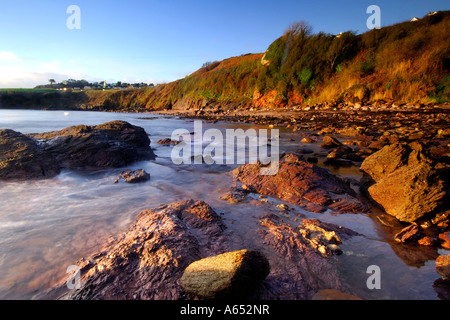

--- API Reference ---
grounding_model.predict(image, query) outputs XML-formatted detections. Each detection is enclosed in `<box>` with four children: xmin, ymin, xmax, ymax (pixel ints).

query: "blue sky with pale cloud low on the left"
<box><xmin>0</xmin><ymin>0</ymin><xmax>450</xmax><ymax>88</ymax></box>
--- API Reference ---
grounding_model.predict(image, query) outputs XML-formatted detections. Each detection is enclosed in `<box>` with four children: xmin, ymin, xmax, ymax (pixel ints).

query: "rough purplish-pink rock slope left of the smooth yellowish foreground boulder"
<box><xmin>55</xmin><ymin>200</ymin><xmax>227</xmax><ymax>300</ymax></box>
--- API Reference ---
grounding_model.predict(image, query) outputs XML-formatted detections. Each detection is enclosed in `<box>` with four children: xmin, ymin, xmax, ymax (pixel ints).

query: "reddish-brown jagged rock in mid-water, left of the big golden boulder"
<box><xmin>233</xmin><ymin>154</ymin><xmax>367</xmax><ymax>213</ymax></box>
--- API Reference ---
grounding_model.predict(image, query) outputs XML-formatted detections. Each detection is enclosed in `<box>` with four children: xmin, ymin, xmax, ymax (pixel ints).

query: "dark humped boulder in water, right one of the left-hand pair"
<box><xmin>32</xmin><ymin>121</ymin><xmax>155</xmax><ymax>169</ymax></box>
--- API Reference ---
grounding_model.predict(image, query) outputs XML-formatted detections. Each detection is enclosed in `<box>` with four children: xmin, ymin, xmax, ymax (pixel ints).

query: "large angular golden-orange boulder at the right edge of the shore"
<box><xmin>361</xmin><ymin>143</ymin><xmax>447</xmax><ymax>222</ymax></box>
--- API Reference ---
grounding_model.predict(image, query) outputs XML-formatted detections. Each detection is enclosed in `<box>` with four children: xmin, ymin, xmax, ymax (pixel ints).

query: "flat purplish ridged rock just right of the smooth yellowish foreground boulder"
<box><xmin>257</xmin><ymin>214</ymin><xmax>358</xmax><ymax>300</ymax></box>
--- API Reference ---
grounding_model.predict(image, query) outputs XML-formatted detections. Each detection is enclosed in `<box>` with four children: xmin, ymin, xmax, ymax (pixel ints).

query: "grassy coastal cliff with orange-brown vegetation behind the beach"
<box><xmin>0</xmin><ymin>11</ymin><xmax>450</xmax><ymax>112</ymax></box>
